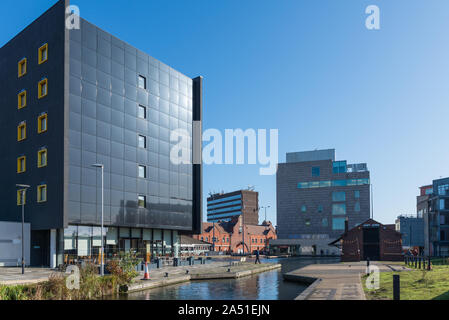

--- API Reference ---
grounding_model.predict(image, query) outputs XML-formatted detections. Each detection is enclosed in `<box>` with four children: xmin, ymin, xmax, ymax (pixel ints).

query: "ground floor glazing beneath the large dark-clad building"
<box><xmin>48</xmin><ymin>225</ymin><xmax>180</xmax><ymax>267</ymax></box>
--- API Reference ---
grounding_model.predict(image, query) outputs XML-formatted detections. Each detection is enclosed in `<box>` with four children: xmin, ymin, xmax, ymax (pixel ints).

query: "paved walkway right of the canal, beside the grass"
<box><xmin>284</xmin><ymin>261</ymin><xmax>409</xmax><ymax>300</ymax></box>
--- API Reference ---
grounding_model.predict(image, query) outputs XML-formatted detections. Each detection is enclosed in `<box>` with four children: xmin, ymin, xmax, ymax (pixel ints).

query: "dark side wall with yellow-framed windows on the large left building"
<box><xmin>0</xmin><ymin>1</ymin><xmax>65</xmax><ymax>230</ymax></box>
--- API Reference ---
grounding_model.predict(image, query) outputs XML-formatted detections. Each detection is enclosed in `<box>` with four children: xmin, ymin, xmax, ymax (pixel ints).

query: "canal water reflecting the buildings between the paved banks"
<box><xmin>117</xmin><ymin>257</ymin><xmax>340</xmax><ymax>300</ymax></box>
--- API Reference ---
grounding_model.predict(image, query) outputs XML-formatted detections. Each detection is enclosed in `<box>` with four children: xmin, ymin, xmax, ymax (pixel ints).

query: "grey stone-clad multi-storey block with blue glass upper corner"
<box><xmin>272</xmin><ymin>149</ymin><xmax>371</xmax><ymax>254</ymax></box>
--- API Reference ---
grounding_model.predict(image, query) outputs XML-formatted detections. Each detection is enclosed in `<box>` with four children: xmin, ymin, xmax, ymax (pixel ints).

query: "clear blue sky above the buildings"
<box><xmin>0</xmin><ymin>0</ymin><xmax>449</xmax><ymax>223</ymax></box>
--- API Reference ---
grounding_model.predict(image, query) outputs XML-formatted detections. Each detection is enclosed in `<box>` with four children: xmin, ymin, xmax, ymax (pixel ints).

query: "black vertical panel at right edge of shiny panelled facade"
<box><xmin>192</xmin><ymin>77</ymin><xmax>203</xmax><ymax>233</ymax></box>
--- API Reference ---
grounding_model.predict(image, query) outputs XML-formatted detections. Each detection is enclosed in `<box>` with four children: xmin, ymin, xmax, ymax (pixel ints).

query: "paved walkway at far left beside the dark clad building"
<box><xmin>0</xmin><ymin>267</ymin><xmax>60</xmax><ymax>285</ymax></box>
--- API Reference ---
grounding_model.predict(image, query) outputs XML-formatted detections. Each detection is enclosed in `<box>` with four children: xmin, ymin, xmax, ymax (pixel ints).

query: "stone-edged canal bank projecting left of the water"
<box><xmin>123</xmin><ymin>262</ymin><xmax>281</xmax><ymax>293</ymax></box>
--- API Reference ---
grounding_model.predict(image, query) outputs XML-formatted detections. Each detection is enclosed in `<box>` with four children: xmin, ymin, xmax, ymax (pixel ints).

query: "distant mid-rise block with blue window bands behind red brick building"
<box><xmin>207</xmin><ymin>190</ymin><xmax>259</xmax><ymax>225</ymax></box>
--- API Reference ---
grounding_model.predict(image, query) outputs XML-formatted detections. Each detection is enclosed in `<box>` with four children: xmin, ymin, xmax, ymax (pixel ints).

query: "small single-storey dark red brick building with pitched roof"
<box><xmin>329</xmin><ymin>219</ymin><xmax>403</xmax><ymax>261</ymax></box>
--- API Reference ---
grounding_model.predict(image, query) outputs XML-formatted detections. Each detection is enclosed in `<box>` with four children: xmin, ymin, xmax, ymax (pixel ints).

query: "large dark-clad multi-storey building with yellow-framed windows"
<box><xmin>0</xmin><ymin>1</ymin><xmax>202</xmax><ymax>266</ymax></box>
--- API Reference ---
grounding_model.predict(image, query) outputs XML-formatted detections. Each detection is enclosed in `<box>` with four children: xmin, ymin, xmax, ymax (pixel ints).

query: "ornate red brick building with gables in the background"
<box><xmin>192</xmin><ymin>216</ymin><xmax>276</xmax><ymax>253</ymax></box>
